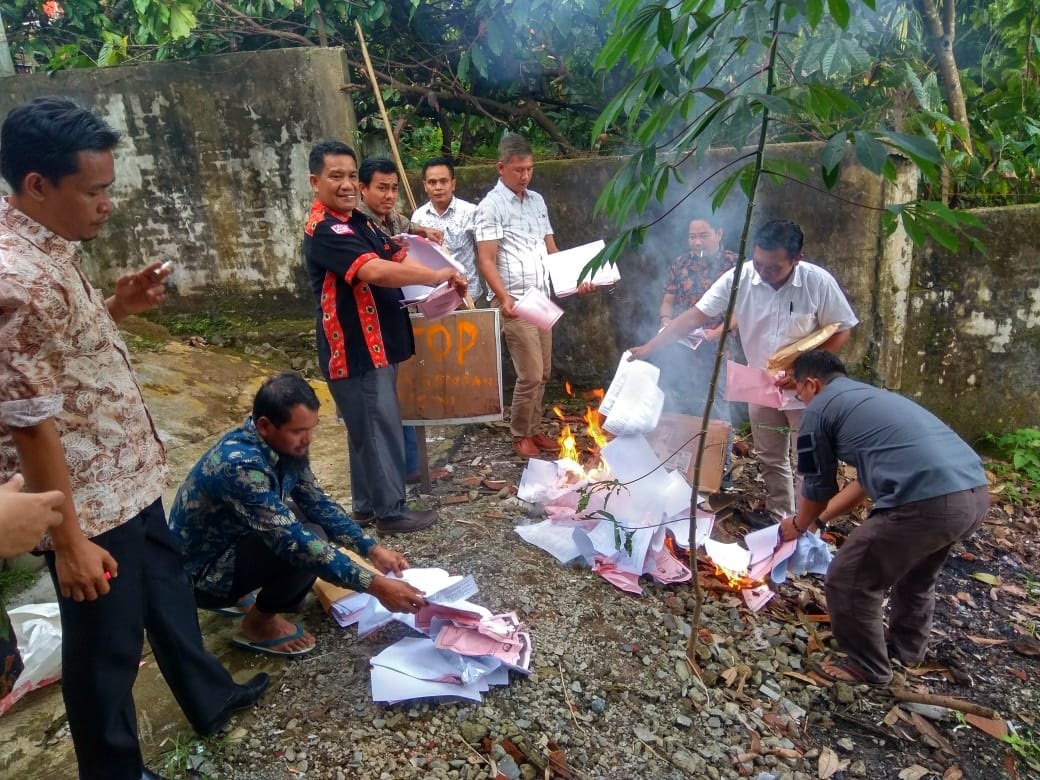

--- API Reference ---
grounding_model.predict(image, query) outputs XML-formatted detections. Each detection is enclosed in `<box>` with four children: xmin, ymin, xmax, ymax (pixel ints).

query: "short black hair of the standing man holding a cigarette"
<box><xmin>0</xmin><ymin>96</ymin><xmax>120</xmax><ymax>192</ymax></box>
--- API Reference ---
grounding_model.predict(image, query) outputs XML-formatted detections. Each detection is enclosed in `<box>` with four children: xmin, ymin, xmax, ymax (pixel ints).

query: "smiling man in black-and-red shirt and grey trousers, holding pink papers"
<box><xmin>304</xmin><ymin>141</ymin><xmax>466</xmax><ymax>534</ymax></box>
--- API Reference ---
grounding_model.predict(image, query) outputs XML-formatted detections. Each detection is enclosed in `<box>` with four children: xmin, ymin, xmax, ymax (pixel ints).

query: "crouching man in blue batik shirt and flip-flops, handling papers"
<box><xmin>170</xmin><ymin>373</ymin><xmax>425</xmax><ymax>655</ymax></box>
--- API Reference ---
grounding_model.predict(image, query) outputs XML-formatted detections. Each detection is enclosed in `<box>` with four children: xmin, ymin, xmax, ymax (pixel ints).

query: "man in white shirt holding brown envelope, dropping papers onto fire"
<box><xmin>631</xmin><ymin>219</ymin><xmax>859</xmax><ymax>518</ymax></box>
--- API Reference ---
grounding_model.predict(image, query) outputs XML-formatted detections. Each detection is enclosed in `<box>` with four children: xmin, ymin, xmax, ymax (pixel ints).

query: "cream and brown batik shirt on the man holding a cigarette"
<box><xmin>0</xmin><ymin>201</ymin><xmax>166</xmax><ymax>550</ymax></box>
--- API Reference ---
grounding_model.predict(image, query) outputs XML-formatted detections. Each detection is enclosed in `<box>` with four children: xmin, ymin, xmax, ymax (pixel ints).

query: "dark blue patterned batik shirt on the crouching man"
<box><xmin>170</xmin><ymin>418</ymin><xmax>376</xmax><ymax>597</ymax></box>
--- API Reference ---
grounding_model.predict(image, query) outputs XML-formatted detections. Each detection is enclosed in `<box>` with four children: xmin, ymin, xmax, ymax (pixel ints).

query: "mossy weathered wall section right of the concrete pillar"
<box><xmin>903</xmin><ymin>205</ymin><xmax>1040</xmax><ymax>441</ymax></box>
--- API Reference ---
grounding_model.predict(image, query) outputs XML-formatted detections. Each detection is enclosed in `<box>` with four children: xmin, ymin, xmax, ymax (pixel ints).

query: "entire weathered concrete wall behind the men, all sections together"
<box><xmin>0</xmin><ymin>49</ymin><xmax>1040</xmax><ymax>437</ymax></box>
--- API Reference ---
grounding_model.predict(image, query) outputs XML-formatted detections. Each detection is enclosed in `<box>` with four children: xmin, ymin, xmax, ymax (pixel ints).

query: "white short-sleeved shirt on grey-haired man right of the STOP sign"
<box><xmin>473</xmin><ymin>180</ymin><xmax>552</xmax><ymax>301</ymax></box>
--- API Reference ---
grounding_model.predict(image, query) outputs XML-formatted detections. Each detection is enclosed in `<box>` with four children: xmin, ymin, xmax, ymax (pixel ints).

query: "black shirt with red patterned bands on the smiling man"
<box><xmin>304</xmin><ymin>201</ymin><xmax>415</xmax><ymax>380</ymax></box>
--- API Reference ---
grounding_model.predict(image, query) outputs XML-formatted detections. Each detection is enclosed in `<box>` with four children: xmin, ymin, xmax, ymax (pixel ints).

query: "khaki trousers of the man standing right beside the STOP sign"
<box><xmin>491</xmin><ymin>297</ymin><xmax>552</xmax><ymax>437</ymax></box>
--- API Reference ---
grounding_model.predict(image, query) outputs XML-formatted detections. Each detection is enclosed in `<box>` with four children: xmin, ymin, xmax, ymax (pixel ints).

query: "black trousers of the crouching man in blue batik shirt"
<box><xmin>196</xmin><ymin>526</ymin><xmax>328</xmax><ymax>614</ymax></box>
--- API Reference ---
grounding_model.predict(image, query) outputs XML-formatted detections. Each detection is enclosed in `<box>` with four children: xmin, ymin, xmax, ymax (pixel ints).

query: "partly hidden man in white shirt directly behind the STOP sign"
<box><xmin>412</xmin><ymin>157</ymin><xmax>484</xmax><ymax>301</ymax></box>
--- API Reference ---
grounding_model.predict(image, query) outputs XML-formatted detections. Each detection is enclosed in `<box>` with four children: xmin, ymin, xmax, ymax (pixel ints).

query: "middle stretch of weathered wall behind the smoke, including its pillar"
<box><xmin>445</xmin><ymin>144</ymin><xmax>886</xmax><ymax>391</ymax></box>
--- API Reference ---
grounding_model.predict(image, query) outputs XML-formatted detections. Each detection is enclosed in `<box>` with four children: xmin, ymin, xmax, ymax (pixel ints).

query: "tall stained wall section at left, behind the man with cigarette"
<box><xmin>0</xmin><ymin>49</ymin><xmax>356</xmax><ymax>294</ymax></box>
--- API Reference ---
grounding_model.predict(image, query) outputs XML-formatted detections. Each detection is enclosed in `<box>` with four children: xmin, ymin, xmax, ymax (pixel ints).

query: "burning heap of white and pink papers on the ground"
<box><xmin>507</xmin><ymin>354</ymin><xmax>830</xmax><ymax>610</ymax></box>
